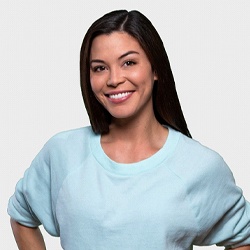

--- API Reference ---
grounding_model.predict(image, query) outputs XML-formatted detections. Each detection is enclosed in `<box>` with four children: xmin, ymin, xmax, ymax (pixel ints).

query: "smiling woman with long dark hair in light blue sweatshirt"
<box><xmin>8</xmin><ymin>10</ymin><xmax>250</xmax><ymax>250</ymax></box>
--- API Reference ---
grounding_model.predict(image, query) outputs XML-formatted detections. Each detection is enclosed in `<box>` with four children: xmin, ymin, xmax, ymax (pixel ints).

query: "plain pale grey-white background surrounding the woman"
<box><xmin>0</xmin><ymin>0</ymin><xmax>250</xmax><ymax>250</ymax></box>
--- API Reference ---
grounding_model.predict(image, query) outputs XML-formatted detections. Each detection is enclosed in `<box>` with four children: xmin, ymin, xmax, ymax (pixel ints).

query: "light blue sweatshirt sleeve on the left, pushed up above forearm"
<box><xmin>8</xmin><ymin>142</ymin><xmax>59</xmax><ymax>236</ymax></box>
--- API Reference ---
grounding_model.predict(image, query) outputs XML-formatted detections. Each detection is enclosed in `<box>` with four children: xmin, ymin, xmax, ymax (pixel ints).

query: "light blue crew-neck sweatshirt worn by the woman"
<box><xmin>8</xmin><ymin>127</ymin><xmax>250</xmax><ymax>250</ymax></box>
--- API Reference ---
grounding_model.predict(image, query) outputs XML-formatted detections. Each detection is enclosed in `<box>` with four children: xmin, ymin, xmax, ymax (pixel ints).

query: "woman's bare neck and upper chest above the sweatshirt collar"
<box><xmin>101</xmin><ymin>112</ymin><xmax>168</xmax><ymax>163</ymax></box>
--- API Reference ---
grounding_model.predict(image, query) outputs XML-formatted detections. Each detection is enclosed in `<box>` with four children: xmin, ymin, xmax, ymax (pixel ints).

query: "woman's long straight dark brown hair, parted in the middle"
<box><xmin>80</xmin><ymin>10</ymin><xmax>191</xmax><ymax>137</ymax></box>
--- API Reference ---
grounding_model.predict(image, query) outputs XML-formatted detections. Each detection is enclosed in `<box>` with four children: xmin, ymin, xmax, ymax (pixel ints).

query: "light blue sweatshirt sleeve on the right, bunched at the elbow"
<box><xmin>191</xmin><ymin>157</ymin><xmax>250</xmax><ymax>249</ymax></box>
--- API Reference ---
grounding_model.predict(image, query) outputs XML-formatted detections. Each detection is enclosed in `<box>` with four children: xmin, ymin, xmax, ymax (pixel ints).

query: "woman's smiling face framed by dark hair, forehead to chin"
<box><xmin>90</xmin><ymin>32</ymin><xmax>157</xmax><ymax>119</ymax></box>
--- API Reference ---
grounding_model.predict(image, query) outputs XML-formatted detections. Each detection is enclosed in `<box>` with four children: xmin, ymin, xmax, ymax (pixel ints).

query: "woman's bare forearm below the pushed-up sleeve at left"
<box><xmin>10</xmin><ymin>219</ymin><xmax>46</xmax><ymax>250</ymax></box>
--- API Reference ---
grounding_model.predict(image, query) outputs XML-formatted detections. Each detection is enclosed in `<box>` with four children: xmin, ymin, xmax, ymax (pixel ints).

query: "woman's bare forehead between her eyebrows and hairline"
<box><xmin>90</xmin><ymin>32</ymin><xmax>145</xmax><ymax>58</ymax></box>
